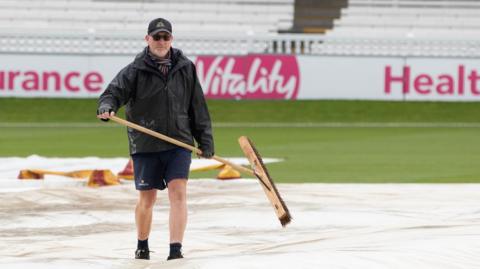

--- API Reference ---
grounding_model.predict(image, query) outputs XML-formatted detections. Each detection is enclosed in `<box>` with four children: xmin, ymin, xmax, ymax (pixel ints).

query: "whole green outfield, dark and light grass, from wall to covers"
<box><xmin>0</xmin><ymin>98</ymin><xmax>480</xmax><ymax>182</ymax></box>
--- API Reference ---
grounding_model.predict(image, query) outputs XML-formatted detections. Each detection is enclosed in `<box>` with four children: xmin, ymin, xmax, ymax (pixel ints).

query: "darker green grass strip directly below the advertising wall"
<box><xmin>0</xmin><ymin>98</ymin><xmax>480</xmax><ymax>122</ymax></box>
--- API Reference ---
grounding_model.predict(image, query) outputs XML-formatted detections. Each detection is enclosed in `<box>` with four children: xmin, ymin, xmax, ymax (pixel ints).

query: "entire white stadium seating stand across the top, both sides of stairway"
<box><xmin>0</xmin><ymin>0</ymin><xmax>480</xmax><ymax>57</ymax></box>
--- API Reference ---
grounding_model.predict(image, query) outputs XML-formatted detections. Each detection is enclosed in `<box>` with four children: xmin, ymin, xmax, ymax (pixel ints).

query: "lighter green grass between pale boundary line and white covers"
<box><xmin>0</xmin><ymin>123</ymin><xmax>480</xmax><ymax>182</ymax></box>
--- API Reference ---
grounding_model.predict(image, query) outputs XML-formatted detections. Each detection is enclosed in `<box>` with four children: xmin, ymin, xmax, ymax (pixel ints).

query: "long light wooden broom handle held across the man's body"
<box><xmin>110</xmin><ymin>116</ymin><xmax>255</xmax><ymax>176</ymax></box>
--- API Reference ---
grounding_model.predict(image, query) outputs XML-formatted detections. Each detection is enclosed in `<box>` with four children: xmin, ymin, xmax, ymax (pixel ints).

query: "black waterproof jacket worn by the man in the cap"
<box><xmin>98</xmin><ymin>47</ymin><xmax>214</xmax><ymax>154</ymax></box>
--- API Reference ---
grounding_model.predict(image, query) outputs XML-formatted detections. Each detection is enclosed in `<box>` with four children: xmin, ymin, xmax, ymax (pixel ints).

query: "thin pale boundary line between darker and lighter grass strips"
<box><xmin>0</xmin><ymin>122</ymin><xmax>480</xmax><ymax>128</ymax></box>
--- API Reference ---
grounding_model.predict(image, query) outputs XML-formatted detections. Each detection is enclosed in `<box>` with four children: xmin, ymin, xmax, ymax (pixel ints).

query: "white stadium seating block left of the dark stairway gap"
<box><xmin>0</xmin><ymin>0</ymin><xmax>294</xmax><ymax>54</ymax></box>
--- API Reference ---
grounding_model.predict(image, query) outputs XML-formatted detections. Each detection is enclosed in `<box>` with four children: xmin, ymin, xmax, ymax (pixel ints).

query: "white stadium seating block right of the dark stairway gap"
<box><xmin>313</xmin><ymin>0</ymin><xmax>480</xmax><ymax>57</ymax></box>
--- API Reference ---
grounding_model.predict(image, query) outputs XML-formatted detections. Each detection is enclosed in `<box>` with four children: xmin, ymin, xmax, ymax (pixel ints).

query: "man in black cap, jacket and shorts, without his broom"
<box><xmin>97</xmin><ymin>18</ymin><xmax>214</xmax><ymax>260</ymax></box>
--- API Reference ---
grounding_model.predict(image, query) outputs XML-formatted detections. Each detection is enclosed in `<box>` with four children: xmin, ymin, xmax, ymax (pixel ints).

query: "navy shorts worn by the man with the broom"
<box><xmin>132</xmin><ymin>148</ymin><xmax>192</xmax><ymax>190</ymax></box>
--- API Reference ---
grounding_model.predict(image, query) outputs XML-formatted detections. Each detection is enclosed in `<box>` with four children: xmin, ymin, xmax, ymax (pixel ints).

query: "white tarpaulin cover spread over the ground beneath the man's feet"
<box><xmin>0</xmin><ymin>157</ymin><xmax>480</xmax><ymax>269</ymax></box>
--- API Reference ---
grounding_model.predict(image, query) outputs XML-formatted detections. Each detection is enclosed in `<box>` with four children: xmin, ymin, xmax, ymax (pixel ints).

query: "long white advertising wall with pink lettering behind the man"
<box><xmin>0</xmin><ymin>54</ymin><xmax>480</xmax><ymax>101</ymax></box>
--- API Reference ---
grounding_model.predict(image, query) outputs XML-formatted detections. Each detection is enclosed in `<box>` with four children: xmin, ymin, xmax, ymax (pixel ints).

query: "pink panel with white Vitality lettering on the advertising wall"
<box><xmin>195</xmin><ymin>55</ymin><xmax>300</xmax><ymax>99</ymax></box>
